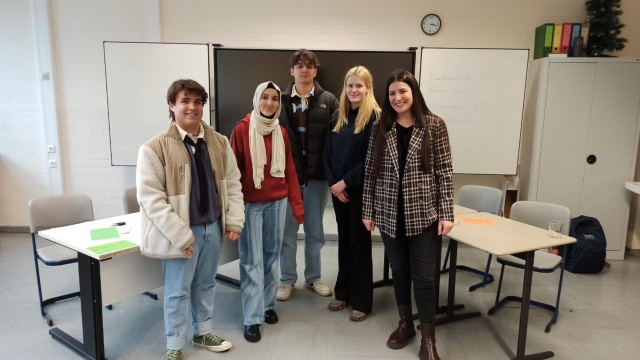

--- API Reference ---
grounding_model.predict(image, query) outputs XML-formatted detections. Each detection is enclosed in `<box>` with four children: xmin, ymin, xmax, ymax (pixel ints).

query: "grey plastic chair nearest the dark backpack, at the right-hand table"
<box><xmin>489</xmin><ymin>201</ymin><xmax>571</xmax><ymax>332</ymax></box>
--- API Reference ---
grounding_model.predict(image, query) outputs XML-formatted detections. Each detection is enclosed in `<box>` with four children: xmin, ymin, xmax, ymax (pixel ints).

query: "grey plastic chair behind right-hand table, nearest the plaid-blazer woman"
<box><xmin>440</xmin><ymin>185</ymin><xmax>504</xmax><ymax>291</ymax></box>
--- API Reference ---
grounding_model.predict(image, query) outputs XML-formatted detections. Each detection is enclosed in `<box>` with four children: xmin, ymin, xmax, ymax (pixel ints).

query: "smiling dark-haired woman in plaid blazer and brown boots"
<box><xmin>362</xmin><ymin>70</ymin><xmax>453</xmax><ymax>360</ymax></box>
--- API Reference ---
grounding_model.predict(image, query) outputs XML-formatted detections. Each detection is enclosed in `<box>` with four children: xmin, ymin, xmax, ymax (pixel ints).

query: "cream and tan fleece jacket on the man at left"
<box><xmin>136</xmin><ymin>122</ymin><xmax>244</xmax><ymax>259</ymax></box>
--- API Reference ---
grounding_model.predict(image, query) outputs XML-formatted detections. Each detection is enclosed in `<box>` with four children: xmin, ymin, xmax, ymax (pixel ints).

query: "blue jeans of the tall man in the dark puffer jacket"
<box><xmin>280</xmin><ymin>180</ymin><xmax>329</xmax><ymax>285</ymax></box>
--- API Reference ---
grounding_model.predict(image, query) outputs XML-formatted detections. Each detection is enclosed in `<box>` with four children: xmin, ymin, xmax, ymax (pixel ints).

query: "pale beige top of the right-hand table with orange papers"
<box><xmin>447</xmin><ymin>212</ymin><xmax>576</xmax><ymax>256</ymax></box>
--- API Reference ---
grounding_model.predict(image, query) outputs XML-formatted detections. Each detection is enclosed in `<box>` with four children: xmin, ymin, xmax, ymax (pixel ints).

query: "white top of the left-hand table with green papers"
<box><xmin>38</xmin><ymin>213</ymin><xmax>140</xmax><ymax>260</ymax></box>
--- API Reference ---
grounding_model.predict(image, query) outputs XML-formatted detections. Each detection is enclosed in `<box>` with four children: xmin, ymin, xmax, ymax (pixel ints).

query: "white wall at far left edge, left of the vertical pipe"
<box><xmin>0</xmin><ymin>0</ymin><xmax>49</xmax><ymax>226</ymax></box>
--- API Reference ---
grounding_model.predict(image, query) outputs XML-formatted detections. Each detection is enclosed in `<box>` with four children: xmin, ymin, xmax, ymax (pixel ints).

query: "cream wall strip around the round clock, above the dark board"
<box><xmin>161</xmin><ymin>0</ymin><xmax>584</xmax><ymax>49</ymax></box>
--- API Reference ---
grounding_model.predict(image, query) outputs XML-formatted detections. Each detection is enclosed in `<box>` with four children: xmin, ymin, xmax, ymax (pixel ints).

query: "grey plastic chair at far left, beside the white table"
<box><xmin>29</xmin><ymin>194</ymin><xmax>93</xmax><ymax>326</ymax></box>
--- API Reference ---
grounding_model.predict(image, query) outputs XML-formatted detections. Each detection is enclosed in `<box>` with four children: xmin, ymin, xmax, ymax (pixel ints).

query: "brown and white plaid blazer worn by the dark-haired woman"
<box><xmin>362</xmin><ymin>114</ymin><xmax>453</xmax><ymax>238</ymax></box>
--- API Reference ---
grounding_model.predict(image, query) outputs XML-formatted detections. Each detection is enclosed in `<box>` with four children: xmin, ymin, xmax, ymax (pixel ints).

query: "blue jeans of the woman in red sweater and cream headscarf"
<box><xmin>238</xmin><ymin>198</ymin><xmax>287</xmax><ymax>325</ymax></box>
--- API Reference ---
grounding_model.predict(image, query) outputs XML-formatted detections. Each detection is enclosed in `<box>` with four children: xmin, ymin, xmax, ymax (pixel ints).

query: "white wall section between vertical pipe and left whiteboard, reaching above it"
<box><xmin>50</xmin><ymin>0</ymin><xmax>160</xmax><ymax>218</ymax></box>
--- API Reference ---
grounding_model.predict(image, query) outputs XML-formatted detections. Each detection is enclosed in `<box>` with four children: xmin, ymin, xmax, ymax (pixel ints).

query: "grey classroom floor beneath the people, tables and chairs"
<box><xmin>0</xmin><ymin>226</ymin><xmax>640</xmax><ymax>360</ymax></box>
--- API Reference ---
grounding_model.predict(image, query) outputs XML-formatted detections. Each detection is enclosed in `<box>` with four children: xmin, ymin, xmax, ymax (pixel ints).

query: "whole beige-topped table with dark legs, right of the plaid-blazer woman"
<box><xmin>438</xmin><ymin>212</ymin><xmax>576</xmax><ymax>360</ymax></box>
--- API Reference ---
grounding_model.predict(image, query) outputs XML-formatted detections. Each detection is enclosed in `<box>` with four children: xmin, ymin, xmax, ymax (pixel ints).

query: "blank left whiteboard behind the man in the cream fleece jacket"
<box><xmin>103</xmin><ymin>41</ymin><xmax>211</xmax><ymax>166</ymax></box>
